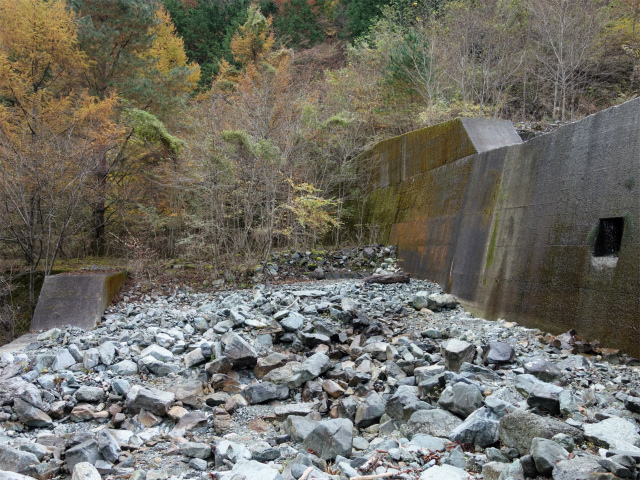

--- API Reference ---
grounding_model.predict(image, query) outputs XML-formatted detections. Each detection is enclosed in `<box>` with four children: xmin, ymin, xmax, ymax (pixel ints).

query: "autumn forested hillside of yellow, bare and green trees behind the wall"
<box><xmin>0</xmin><ymin>0</ymin><xmax>640</xmax><ymax>324</ymax></box>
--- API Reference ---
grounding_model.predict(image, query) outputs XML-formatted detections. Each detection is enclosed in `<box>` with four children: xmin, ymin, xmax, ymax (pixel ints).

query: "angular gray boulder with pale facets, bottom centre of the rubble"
<box><xmin>303</xmin><ymin>418</ymin><xmax>353</xmax><ymax>460</ymax></box>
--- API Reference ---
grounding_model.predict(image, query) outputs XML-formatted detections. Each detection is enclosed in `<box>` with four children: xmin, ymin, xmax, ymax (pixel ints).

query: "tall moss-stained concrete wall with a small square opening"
<box><xmin>369</xmin><ymin>100</ymin><xmax>640</xmax><ymax>357</ymax></box>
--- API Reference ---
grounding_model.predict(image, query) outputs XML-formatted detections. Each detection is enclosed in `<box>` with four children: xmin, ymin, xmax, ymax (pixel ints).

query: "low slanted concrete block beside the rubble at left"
<box><xmin>30</xmin><ymin>272</ymin><xmax>127</xmax><ymax>332</ymax></box>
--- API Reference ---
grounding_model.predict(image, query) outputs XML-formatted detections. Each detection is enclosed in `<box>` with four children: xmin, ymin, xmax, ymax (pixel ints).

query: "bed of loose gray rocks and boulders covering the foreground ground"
<box><xmin>0</xmin><ymin>249</ymin><xmax>640</xmax><ymax>480</ymax></box>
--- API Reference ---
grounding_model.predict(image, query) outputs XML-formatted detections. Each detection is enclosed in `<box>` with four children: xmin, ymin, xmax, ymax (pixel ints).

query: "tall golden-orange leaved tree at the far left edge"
<box><xmin>0</xmin><ymin>0</ymin><xmax>121</xmax><ymax>305</ymax></box>
